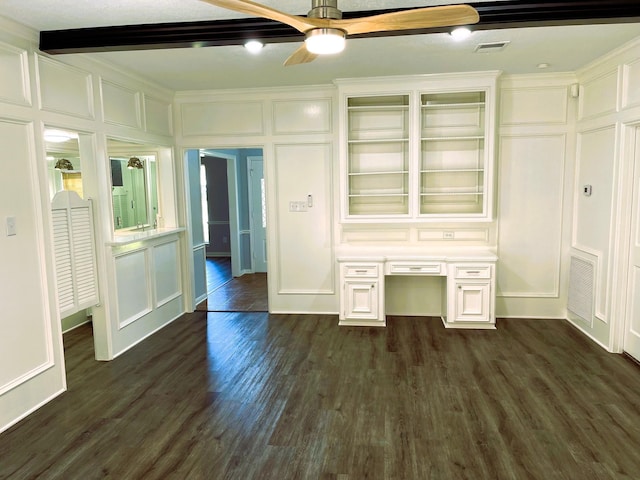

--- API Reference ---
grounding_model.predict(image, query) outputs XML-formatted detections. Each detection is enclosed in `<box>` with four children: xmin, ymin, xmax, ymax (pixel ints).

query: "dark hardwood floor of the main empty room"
<box><xmin>0</xmin><ymin>312</ymin><xmax>640</xmax><ymax>480</ymax></box>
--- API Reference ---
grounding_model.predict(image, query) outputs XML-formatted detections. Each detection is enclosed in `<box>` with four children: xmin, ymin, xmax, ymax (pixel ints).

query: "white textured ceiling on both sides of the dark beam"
<box><xmin>0</xmin><ymin>0</ymin><xmax>640</xmax><ymax>91</ymax></box>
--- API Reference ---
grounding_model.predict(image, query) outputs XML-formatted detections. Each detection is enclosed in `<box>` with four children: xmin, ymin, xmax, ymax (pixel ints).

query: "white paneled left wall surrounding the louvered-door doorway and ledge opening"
<box><xmin>0</xmin><ymin>18</ymin><xmax>184</xmax><ymax>431</ymax></box>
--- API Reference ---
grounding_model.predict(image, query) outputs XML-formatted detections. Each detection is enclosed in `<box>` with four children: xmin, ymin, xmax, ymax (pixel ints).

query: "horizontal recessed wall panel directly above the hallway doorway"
<box><xmin>180</xmin><ymin>102</ymin><xmax>264</xmax><ymax>137</ymax></box>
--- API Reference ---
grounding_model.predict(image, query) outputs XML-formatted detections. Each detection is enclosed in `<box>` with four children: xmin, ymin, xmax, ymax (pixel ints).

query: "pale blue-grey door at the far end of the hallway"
<box><xmin>248</xmin><ymin>157</ymin><xmax>267</xmax><ymax>272</ymax></box>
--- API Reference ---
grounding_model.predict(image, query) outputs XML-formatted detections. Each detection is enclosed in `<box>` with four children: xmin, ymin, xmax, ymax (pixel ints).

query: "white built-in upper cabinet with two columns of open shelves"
<box><xmin>336</xmin><ymin>72</ymin><xmax>498</xmax><ymax>222</ymax></box>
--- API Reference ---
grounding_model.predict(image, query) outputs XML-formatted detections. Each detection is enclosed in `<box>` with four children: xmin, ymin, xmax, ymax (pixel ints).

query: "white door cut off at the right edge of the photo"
<box><xmin>624</xmin><ymin>127</ymin><xmax>640</xmax><ymax>360</ymax></box>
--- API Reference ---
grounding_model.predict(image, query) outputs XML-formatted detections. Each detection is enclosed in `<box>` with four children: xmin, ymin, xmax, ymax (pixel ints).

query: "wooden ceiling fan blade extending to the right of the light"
<box><xmin>326</xmin><ymin>5</ymin><xmax>480</xmax><ymax>35</ymax></box>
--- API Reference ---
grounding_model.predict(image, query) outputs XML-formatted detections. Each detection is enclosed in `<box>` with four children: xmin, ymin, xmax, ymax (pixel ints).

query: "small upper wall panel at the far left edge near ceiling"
<box><xmin>0</xmin><ymin>42</ymin><xmax>31</xmax><ymax>106</ymax></box>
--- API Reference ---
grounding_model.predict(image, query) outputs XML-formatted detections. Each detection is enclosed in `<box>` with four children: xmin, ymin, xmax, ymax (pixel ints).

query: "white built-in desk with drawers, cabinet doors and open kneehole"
<box><xmin>338</xmin><ymin>248</ymin><xmax>498</xmax><ymax>329</ymax></box>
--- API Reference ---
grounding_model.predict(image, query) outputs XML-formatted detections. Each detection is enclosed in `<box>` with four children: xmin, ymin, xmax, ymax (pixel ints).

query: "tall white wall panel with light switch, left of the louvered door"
<box><xmin>0</xmin><ymin>116</ymin><xmax>65</xmax><ymax>431</ymax></box>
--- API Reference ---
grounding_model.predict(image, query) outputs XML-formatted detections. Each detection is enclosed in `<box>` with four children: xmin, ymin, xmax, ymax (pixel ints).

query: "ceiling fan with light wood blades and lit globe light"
<box><xmin>202</xmin><ymin>0</ymin><xmax>480</xmax><ymax>66</ymax></box>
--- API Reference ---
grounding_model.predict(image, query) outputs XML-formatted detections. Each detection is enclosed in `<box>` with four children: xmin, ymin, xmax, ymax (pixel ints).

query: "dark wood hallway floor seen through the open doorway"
<box><xmin>196</xmin><ymin>257</ymin><xmax>269</xmax><ymax>312</ymax></box>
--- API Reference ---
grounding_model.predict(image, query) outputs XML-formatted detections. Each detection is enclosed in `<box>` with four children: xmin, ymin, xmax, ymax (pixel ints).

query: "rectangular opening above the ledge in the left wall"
<box><xmin>109</xmin><ymin>141</ymin><xmax>159</xmax><ymax>231</ymax></box>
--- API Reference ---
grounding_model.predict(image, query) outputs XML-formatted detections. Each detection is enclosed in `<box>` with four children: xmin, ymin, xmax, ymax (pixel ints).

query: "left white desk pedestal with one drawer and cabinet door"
<box><xmin>340</xmin><ymin>263</ymin><xmax>386</xmax><ymax>326</ymax></box>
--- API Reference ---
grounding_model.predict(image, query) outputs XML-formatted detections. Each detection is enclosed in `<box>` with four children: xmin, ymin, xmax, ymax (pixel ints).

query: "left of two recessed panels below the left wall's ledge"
<box><xmin>114</xmin><ymin>250</ymin><xmax>151</xmax><ymax>328</ymax></box>
